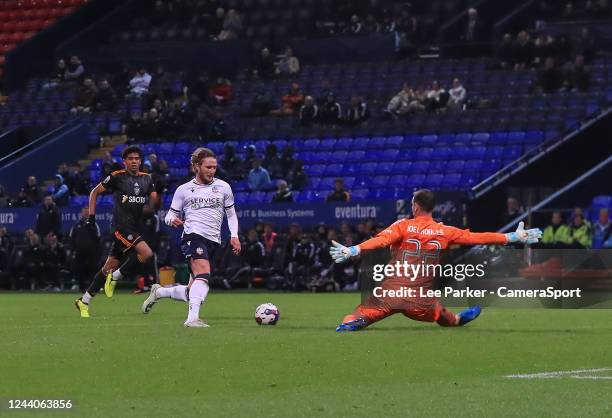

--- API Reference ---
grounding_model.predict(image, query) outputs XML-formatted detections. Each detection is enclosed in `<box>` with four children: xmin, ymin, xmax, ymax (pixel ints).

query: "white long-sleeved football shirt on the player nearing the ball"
<box><xmin>170</xmin><ymin>178</ymin><xmax>234</xmax><ymax>243</ymax></box>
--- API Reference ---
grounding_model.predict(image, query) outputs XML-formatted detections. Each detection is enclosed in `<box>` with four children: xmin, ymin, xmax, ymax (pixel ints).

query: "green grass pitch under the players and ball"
<box><xmin>0</xmin><ymin>292</ymin><xmax>612</xmax><ymax>417</ymax></box>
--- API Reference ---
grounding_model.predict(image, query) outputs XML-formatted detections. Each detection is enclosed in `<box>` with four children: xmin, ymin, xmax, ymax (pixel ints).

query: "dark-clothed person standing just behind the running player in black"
<box><xmin>68</xmin><ymin>206</ymin><xmax>100</xmax><ymax>290</ymax></box>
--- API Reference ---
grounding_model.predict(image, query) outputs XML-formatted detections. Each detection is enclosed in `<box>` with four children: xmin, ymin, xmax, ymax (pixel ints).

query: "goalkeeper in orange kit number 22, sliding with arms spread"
<box><xmin>330</xmin><ymin>189</ymin><xmax>542</xmax><ymax>332</ymax></box>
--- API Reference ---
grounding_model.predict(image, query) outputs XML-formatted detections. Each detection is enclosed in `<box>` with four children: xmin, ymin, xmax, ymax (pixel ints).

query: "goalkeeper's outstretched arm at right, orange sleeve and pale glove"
<box><xmin>446</xmin><ymin>222</ymin><xmax>542</xmax><ymax>245</ymax></box>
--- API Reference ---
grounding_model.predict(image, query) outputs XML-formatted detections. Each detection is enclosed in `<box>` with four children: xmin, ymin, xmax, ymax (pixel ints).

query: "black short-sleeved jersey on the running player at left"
<box><xmin>101</xmin><ymin>170</ymin><xmax>155</xmax><ymax>230</ymax></box>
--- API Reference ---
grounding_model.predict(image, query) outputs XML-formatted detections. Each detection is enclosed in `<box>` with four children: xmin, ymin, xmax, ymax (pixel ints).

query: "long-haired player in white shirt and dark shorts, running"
<box><xmin>142</xmin><ymin>148</ymin><xmax>240</xmax><ymax>328</ymax></box>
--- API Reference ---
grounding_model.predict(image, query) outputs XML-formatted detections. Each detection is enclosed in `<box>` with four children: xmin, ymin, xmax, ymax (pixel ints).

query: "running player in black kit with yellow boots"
<box><xmin>74</xmin><ymin>146</ymin><xmax>159</xmax><ymax>318</ymax></box>
